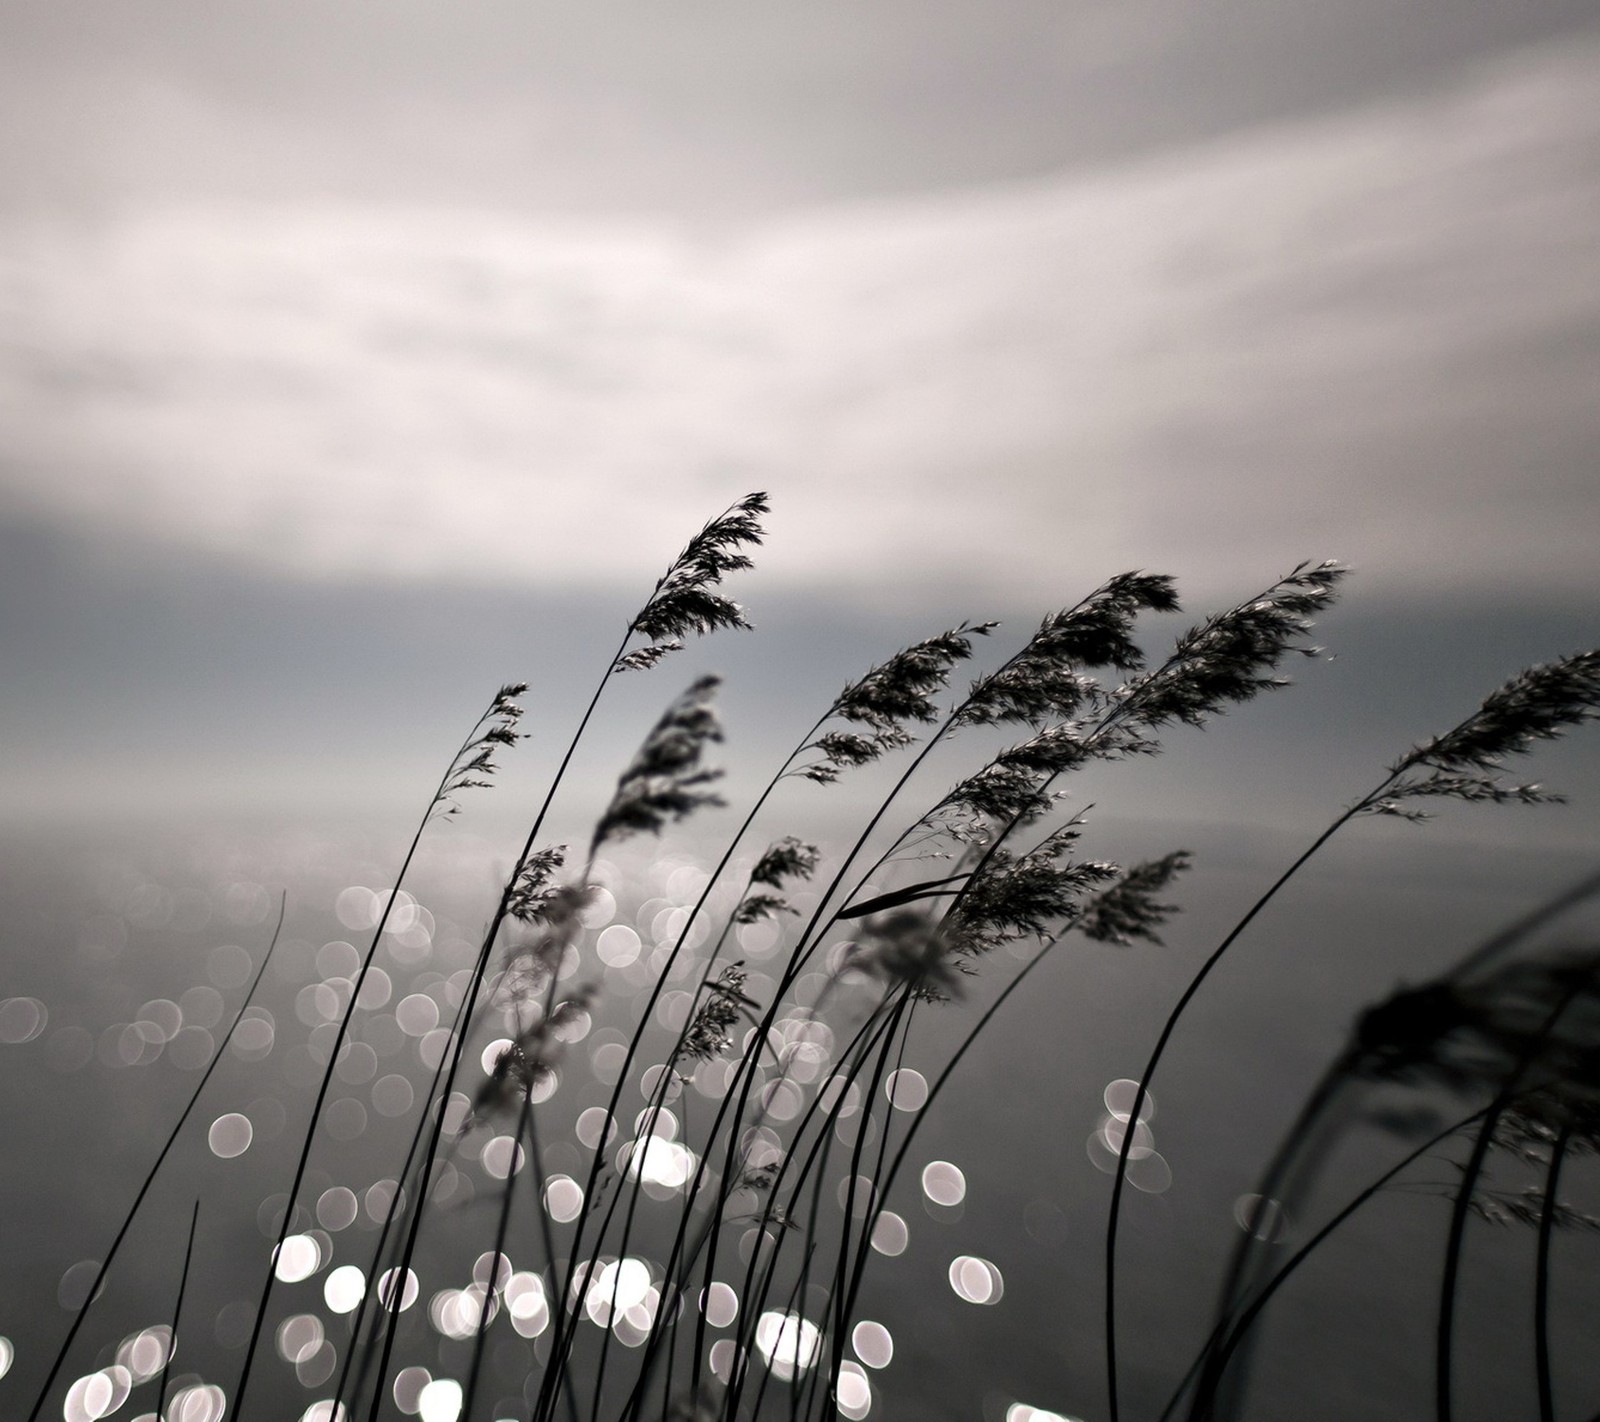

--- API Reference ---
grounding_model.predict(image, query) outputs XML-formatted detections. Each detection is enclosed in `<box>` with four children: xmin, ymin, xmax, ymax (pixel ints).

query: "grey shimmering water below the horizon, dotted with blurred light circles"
<box><xmin>0</xmin><ymin>809</ymin><xmax>1600</xmax><ymax>1422</ymax></box>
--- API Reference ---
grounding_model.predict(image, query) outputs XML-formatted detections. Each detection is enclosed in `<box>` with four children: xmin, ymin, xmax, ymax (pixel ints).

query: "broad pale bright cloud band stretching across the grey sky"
<box><xmin>0</xmin><ymin>42</ymin><xmax>1600</xmax><ymax>597</ymax></box>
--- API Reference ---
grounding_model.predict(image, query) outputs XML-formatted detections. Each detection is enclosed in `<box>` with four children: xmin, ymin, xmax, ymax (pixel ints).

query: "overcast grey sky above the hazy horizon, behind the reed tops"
<box><xmin>0</xmin><ymin>0</ymin><xmax>1600</xmax><ymax>816</ymax></box>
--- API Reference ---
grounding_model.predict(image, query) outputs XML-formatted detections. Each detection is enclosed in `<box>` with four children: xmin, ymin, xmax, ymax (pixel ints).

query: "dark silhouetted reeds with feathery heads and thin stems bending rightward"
<box><xmin>21</xmin><ymin>494</ymin><xmax>1600</xmax><ymax>1422</ymax></box>
